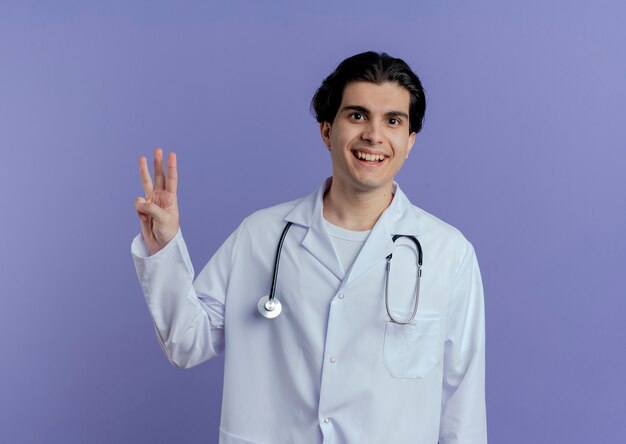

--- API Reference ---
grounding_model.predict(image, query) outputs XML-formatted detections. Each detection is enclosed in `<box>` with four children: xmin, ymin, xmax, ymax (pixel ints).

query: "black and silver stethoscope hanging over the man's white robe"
<box><xmin>258</xmin><ymin>222</ymin><xmax>423</xmax><ymax>325</ymax></box>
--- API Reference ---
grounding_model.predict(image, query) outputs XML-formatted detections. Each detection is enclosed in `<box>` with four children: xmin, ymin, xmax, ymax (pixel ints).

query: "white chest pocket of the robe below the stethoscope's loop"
<box><xmin>383</xmin><ymin>313</ymin><xmax>441</xmax><ymax>379</ymax></box>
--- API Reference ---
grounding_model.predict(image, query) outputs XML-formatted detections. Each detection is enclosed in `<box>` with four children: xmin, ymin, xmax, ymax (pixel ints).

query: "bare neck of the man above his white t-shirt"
<box><xmin>324</xmin><ymin>181</ymin><xmax>393</xmax><ymax>231</ymax></box>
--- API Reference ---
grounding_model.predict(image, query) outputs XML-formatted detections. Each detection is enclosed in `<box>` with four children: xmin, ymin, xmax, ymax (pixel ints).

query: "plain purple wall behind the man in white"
<box><xmin>0</xmin><ymin>0</ymin><xmax>626</xmax><ymax>444</ymax></box>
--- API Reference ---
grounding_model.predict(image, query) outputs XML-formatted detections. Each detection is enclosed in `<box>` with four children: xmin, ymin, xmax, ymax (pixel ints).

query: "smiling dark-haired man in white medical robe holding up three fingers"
<box><xmin>131</xmin><ymin>52</ymin><xmax>487</xmax><ymax>444</ymax></box>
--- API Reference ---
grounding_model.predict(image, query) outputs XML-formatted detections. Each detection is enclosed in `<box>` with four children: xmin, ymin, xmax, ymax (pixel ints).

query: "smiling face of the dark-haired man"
<box><xmin>320</xmin><ymin>82</ymin><xmax>415</xmax><ymax>193</ymax></box>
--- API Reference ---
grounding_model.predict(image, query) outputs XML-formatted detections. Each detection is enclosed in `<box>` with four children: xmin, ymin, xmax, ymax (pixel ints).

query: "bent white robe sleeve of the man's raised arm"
<box><xmin>131</xmin><ymin>224</ymin><xmax>243</xmax><ymax>368</ymax></box>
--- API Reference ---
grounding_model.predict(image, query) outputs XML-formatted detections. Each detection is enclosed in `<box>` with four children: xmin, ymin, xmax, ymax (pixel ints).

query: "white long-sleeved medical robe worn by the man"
<box><xmin>132</xmin><ymin>180</ymin><xmax>487</xmax><ymax>444</ymax></box>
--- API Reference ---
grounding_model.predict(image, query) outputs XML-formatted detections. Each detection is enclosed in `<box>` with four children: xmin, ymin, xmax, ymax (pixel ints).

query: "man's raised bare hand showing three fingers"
<box><xmin>135</xmin><ymin>148</ymin><xmax>179</xmax><ymax>254</ymax></box>
